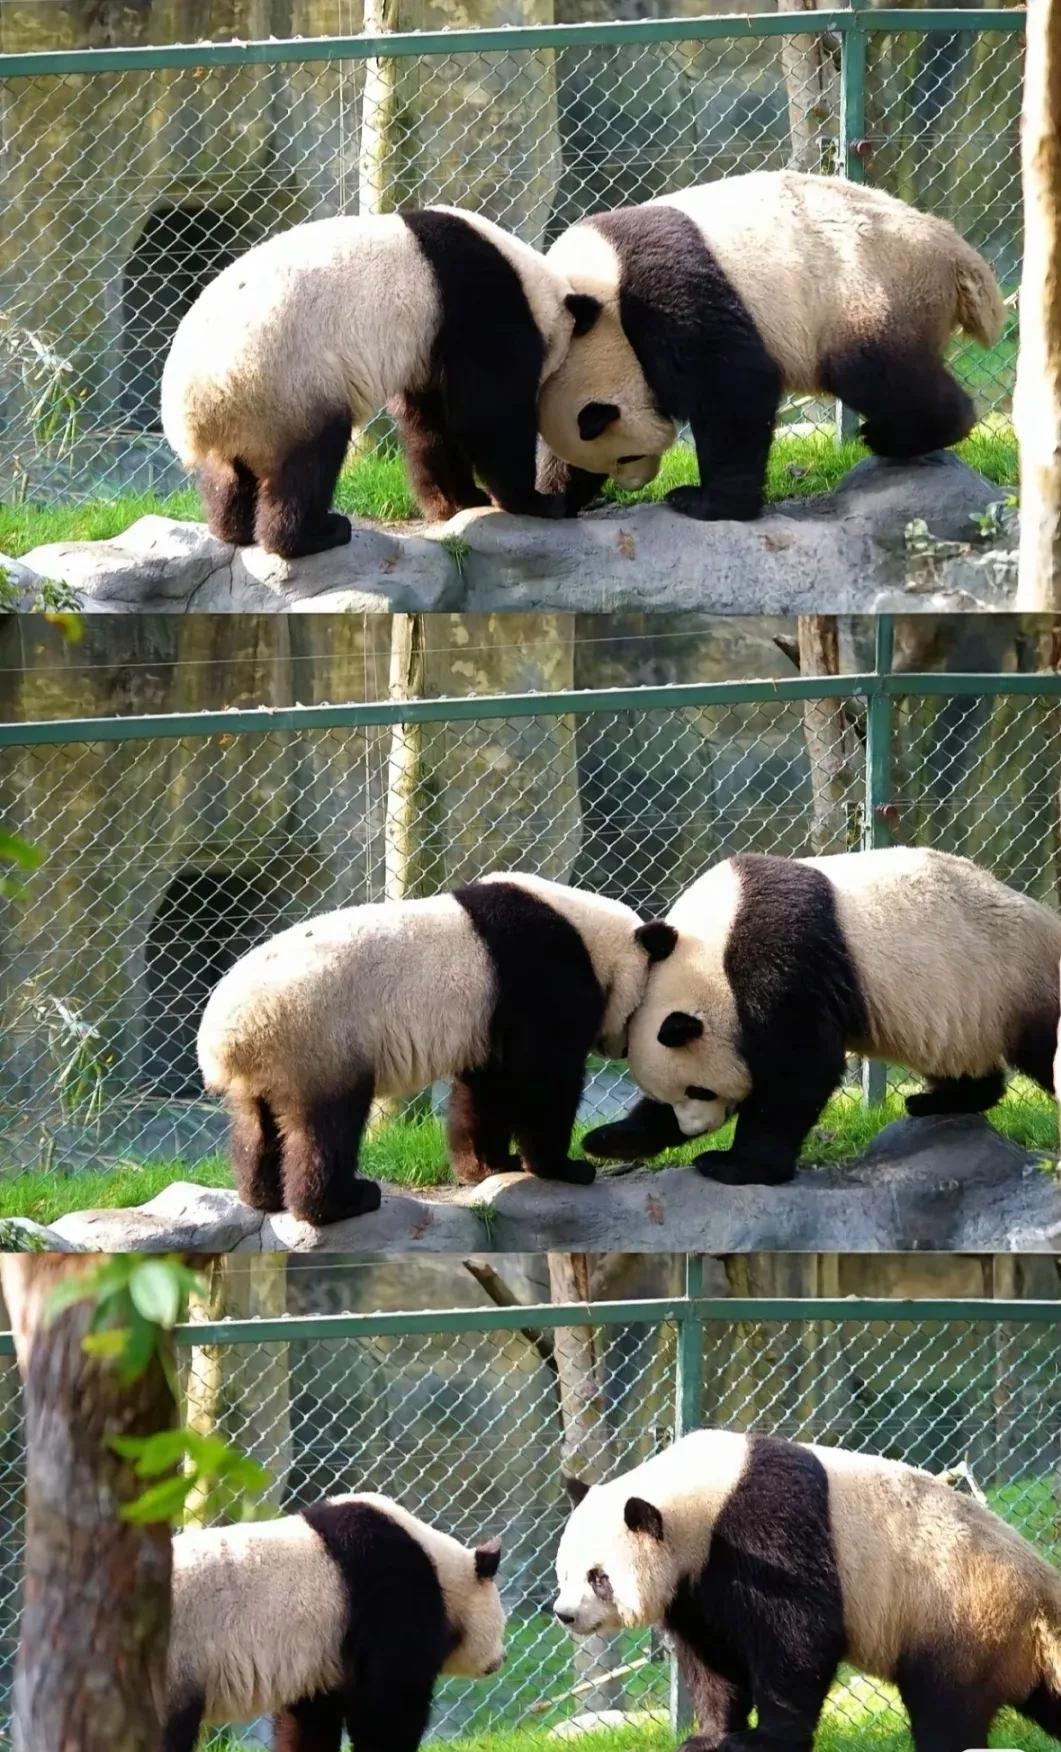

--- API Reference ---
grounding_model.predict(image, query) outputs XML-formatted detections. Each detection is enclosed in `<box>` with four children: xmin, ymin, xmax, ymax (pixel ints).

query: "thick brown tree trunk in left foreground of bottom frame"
<box><xmin>0</xmin><ymin>1254</ymin><xmax>173</xmax><ymax>1752</ymax></box>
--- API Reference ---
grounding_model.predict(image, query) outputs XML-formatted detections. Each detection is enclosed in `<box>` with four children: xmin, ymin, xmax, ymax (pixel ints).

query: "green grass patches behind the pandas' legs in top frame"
<box><xmin>0</xmin><ymin>424</ymin><xmax>1017</xmax><ymax>559</ymax></box>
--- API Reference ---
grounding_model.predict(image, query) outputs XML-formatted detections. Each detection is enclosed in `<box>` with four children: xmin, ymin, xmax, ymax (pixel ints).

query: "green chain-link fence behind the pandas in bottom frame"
<box><xmin>0</xmin><ymin>1282</ymin><xmax>1061</xmax><ymax>1752</ymax></box>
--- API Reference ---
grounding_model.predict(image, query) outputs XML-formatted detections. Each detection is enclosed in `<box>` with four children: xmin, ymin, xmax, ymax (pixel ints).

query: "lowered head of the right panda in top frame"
<box><xmin>538</xmin><ymin>303</ymin><xmax>678</xmax><ymax>489</ymax></box>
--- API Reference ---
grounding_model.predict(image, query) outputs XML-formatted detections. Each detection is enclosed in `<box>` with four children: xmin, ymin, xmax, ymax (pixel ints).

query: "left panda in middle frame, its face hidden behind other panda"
<box><xmin>198</xmin><ymin>874</ymin><xmax>665</xmax><ymax>1225</ymax></box>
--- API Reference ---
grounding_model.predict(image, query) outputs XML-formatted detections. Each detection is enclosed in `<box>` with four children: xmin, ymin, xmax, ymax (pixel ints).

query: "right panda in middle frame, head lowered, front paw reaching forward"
<box><xmin>583</xmin><ymin>848</ymin><xmax>1061</xmax><ymax>1186</ymax></box>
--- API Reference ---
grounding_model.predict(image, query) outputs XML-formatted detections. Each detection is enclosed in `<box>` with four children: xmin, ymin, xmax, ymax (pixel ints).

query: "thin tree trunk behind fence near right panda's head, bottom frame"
<box><xmin>548</xmin><ymin>1253</ymin><xmax>623</xmax><ymax>1715</ymax></box>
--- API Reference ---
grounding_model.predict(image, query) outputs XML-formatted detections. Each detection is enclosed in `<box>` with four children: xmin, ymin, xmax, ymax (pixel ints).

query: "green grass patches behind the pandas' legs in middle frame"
<box><xmin>0</xmin><ymin>1077</ymin><xmax>1057</xmax><ymax>1223</ymax></box>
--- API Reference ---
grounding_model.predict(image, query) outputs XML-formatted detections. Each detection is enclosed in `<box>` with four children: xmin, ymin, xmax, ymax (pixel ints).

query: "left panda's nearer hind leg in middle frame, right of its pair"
<box><xmin>278</xmin><ymin>1077</ymin><xmax>380</xmax><ymax>1228</ymax></box>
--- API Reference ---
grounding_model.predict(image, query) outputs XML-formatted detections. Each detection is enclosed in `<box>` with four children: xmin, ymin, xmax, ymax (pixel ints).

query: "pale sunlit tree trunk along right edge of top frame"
<box><xmin>1014</xmin><ymin>0</ymin><xmax>1061</xmax><ymax>611</ymax></box>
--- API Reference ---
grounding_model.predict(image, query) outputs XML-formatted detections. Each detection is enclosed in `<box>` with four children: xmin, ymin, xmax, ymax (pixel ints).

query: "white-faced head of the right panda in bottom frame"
<box><xmin>553</xmin><ymin>1479</ymin><xmax>681</xmax><ymax>1636</ymax></box>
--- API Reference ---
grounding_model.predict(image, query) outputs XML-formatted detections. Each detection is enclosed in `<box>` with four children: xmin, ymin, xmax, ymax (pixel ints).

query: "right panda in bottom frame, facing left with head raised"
<box><xmin>555</xmin><ymin>1430</ymin><xmax>1061</xmax><ymax>1752</ymax></box>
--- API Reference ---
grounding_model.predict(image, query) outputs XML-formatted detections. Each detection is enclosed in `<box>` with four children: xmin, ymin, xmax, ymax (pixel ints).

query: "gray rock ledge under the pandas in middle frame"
<box><xmin>53</xmin><ymin>1116</ymin><xmax>1061</xmax><ymax>1253</ymax></box>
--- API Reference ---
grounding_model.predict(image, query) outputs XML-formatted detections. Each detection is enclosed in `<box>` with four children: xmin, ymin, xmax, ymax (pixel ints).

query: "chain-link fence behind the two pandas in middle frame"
<box><xmin>0</xmin><ymin>655</ymin><xmax>1061</xmax><ymax>1174</ymax></box>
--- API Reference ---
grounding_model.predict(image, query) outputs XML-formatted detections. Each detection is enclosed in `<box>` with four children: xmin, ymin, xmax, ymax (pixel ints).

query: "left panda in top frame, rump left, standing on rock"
<box><xmin>161</xmin><ymin>207</ymin><xmax>597</xmax><ymax>559</ymax></box>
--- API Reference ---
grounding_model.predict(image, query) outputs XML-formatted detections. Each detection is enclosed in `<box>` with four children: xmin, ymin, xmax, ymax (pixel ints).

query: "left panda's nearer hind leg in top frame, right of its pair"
<box><xmin>254</xmin><ymin>412</ymin><xmax>354</xmax><ymax>559</ymax></box>
